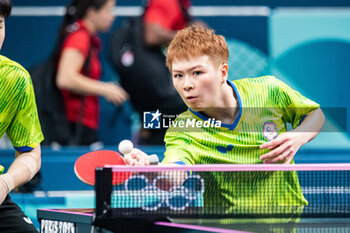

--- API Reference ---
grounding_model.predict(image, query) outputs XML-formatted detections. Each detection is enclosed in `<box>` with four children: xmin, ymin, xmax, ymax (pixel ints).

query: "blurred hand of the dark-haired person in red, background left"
<box><xmin>103</xmin><ymin>82</ymin><xmax>129</xmax><ymax>105</ymax></box>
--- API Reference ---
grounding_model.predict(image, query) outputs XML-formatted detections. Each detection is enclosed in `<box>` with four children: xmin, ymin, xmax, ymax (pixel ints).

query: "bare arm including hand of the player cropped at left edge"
<box><xmin>0</xmin><ymin>145</ymin><xmax>41</xmax><ymax>203</ymax></box>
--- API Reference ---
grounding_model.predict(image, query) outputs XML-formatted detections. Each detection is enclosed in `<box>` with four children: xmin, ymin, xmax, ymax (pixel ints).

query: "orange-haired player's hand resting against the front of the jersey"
<box><xmin>260</xmin><ymin>131</ymin><xmax>307</xmax><ymax>164</ymax></box>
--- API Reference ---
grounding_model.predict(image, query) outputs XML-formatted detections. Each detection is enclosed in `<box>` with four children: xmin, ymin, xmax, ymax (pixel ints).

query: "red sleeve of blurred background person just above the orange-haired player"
<box><xmin>144</xmin><ymin>0</ymin><xmax>182</xmax><ymax>30</ymax></box>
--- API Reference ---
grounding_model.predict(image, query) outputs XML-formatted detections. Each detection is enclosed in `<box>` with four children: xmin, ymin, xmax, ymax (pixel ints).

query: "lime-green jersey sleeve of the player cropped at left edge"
<box><xmin>6</xmin><ymin>69</ymin><xmax>44</xmax><ymax>152</ymax></box>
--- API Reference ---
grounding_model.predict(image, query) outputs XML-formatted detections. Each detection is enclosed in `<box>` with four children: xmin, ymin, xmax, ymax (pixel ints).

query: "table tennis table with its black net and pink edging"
<box><xmin>37</xmin><ymin>164</ymin><xmax>350</xmax><ymax>233</ymax></box>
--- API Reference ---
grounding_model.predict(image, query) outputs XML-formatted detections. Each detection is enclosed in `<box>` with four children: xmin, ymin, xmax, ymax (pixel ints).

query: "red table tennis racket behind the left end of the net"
<box><xmin>74</xmin><ymin>150</ymin><xmax>132</xmax><ymax>185</ymax></box>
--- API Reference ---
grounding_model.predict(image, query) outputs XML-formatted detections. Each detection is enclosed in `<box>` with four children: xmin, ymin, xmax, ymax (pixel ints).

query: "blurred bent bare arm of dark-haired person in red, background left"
<box><xmin>56</xmin><ymin>48</ymin><xmax>129</xmax><ymax>105</ymax></box>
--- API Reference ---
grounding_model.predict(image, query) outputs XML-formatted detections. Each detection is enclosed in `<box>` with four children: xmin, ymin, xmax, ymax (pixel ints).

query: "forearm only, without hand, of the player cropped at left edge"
<box><xmin>7</xmin><ymin>145</ymin><xmax>41</xmax><ymax>187</ymax></box>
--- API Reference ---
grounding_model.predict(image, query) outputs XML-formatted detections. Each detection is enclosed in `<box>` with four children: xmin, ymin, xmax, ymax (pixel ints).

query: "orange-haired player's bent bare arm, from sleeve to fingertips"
<box><xmin>260</xmin><ymin>108</ymin><xmax>325</xmax><ymax>164</ymax></box>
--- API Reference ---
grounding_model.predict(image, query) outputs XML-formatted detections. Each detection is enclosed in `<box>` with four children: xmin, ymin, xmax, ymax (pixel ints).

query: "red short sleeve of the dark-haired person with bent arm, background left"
<box><xmin>62</xmin><ymin>30</ymin><xmax>90</xmax><ymax>58</ymax></box>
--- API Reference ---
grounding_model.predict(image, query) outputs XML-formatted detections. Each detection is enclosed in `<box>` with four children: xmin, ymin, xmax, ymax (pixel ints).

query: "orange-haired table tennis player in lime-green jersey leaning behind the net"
<box><xmin>125</xmin><ymin>26</ymin><xmax>324</xmax><ymax>206</ymax></box>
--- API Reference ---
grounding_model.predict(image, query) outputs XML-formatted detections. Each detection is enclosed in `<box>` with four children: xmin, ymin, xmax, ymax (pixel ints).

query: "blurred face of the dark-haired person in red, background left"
<box><xmin>92</xmin><ymin>0</ymin><xmax>116</xmax><ymax>32</ymax></box>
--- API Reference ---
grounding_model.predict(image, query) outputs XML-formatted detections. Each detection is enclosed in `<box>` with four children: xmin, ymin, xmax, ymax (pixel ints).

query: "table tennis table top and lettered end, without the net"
<box><xmin>37</xmin><ymin>209</ymin><xmax>350</xmax><ymax>233</ymax></box>
